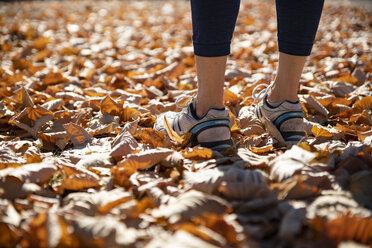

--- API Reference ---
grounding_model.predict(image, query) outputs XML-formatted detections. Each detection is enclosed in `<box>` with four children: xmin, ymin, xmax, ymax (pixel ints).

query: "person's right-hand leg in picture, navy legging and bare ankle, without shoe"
<box><xmin>268</xmin><ymin>0</ymin><xmax>324</xmax><ymax>103</ymax></box>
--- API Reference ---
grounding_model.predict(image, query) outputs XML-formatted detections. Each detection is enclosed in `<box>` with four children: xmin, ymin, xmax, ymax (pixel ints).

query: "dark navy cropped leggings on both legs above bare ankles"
<box><xmin>191</xmin><ymin>0</ymin><xmax>324</xmax><ymax>57</ymax></box>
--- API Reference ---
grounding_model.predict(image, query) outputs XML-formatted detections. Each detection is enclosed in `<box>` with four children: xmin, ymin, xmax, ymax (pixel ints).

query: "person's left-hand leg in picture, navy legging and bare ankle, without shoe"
<box><xmin>191</xmin><ymin>0</ymin><xmax>240</xmax><ymax>116</ymax></box>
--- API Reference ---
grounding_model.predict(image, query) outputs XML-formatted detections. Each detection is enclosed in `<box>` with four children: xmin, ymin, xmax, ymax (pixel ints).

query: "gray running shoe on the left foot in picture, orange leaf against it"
<box><xmin>154</xmin><ymin>97</ymin><xmax>234</xmax><ymax>152</ymax></box>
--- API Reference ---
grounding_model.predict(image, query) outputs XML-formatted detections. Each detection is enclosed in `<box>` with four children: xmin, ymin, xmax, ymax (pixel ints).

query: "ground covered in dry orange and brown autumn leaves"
<box><xmin>0</xmin><ymin>1</ymin><xmax>372</xmax><ymax>248</ymax></box>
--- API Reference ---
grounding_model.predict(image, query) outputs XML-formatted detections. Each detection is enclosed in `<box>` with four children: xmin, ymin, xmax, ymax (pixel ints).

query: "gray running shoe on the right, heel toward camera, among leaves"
<box><xmin>252</xmin><ymin>84</ymin><xmax>306</xmax><ymax>147</ymax></box>
